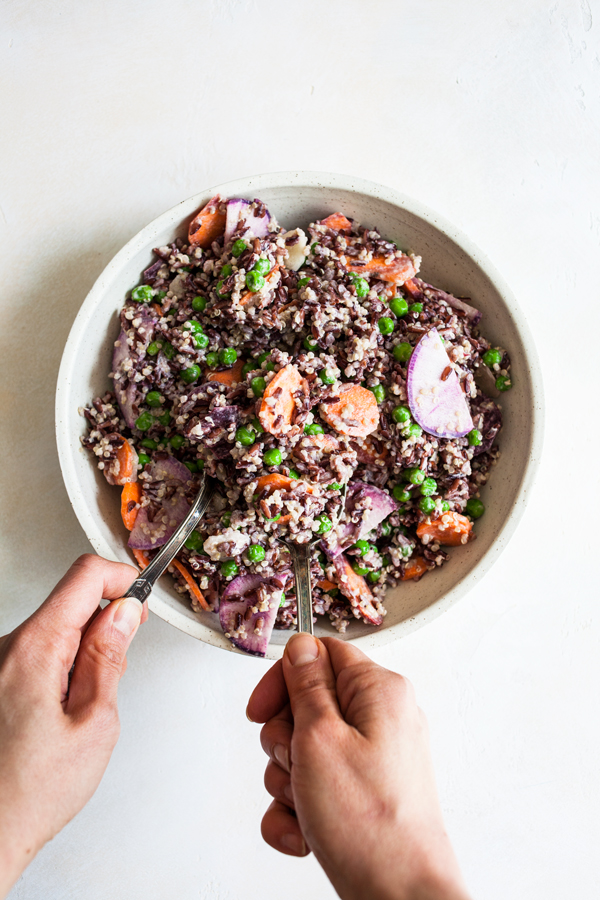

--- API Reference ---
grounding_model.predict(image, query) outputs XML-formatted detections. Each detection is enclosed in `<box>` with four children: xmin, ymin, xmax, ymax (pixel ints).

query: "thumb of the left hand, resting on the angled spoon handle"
<box><xmin>67</xmin><ymin>597</ymin><xmax>143</xmax><ymax>714</ymax></box>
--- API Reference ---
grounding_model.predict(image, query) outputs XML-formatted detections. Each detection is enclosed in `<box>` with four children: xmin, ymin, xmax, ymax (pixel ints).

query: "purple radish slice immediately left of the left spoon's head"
<box><xmin>128</xmin><ymin>456</ymin><xmax>193</xmax><ymax>550</ymax></box>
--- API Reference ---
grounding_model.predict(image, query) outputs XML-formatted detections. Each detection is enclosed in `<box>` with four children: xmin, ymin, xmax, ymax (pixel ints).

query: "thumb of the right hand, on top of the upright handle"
<box><xmin>283</xmin><ymin>633</ymin><xmax>341</xmax><ymax>728</ymax></box>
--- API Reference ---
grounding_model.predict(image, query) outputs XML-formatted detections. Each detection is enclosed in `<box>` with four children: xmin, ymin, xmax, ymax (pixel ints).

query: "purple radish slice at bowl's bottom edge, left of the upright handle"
<box><xmin>219</xmin><ymin>579</ymin><xmax>283</xmax><ymax>656</ymax></box>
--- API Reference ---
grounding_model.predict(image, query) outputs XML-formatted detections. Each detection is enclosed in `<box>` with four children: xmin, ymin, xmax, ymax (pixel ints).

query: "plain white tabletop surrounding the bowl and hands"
<box><xmin>0</xmin><ymin>0</ymin><xmax>600</xmax><ymax>900</ymax></box>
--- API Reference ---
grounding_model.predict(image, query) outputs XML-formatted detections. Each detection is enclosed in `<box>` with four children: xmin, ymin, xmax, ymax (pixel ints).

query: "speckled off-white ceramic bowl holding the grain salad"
<box><xmin>56</xmin><ymin>172</ymin><xmax>543</xmax><ymax>659</ymax></box>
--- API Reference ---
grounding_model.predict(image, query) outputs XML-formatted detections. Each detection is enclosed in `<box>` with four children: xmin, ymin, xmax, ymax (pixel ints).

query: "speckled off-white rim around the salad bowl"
<box><xmin>55</xmin><ymin>172</ymin><xmax>544</xmax><ymax>659</ymax></box>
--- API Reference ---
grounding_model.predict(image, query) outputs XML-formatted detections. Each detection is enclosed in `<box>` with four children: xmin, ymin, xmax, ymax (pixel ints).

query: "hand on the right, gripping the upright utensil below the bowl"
<box><xmin>247</xmin><ymin>634</ymin><xmax>468</xmax><ymax>900</ymax></box>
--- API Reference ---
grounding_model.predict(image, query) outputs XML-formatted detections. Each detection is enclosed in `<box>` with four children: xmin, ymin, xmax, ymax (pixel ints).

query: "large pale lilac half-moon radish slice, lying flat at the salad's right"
<box><xmin>406</xmin><ymin>328</ymin><xmax>473</xmax><ymax>438</ymax></box>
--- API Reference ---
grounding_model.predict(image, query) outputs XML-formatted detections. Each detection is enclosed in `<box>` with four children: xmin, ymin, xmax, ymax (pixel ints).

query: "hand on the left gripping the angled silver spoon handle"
<box><xmin>0</xmin><ymin>555</ymin><xmax>148</xmax><ymax>897</ymax></box>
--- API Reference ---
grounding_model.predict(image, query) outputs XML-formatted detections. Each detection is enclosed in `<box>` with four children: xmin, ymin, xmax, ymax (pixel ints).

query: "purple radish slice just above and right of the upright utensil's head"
<box><xmin>321</xmin><ymin>481</ymin><xmax>398</xmax><ymax>559</ymax></box>
